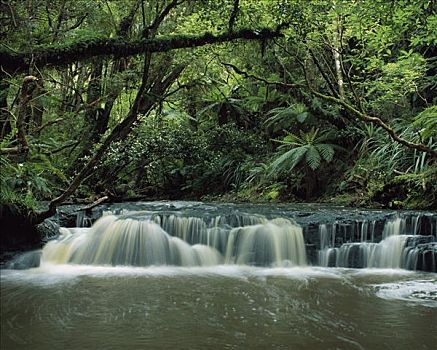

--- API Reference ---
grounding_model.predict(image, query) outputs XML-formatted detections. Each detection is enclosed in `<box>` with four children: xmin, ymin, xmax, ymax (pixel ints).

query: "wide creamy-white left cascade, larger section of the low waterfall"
<box><xmin>41</xmin><ymin>215</ymin><xmax>306</xmax><ymax>266</ymax></box>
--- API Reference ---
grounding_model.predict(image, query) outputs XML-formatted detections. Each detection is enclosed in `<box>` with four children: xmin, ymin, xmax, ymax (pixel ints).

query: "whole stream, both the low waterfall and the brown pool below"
<box><xmin>0</xmin><ymin>203</ymin><xmax>437</xmax><ymax>350</ymax></box>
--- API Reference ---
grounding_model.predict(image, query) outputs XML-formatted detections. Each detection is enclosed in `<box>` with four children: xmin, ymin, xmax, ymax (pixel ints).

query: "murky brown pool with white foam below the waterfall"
<box><xmin>1</xmin><ymin>265</ymin><xmax>437</xmax><ymax>350</ymax></box>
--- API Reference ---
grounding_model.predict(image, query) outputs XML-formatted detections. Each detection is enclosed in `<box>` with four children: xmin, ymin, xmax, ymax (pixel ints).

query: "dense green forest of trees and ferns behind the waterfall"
<box><xmin>0</xmin><ymin>0</ymin><xmax>437</xmax><ymax>219</ymax></box>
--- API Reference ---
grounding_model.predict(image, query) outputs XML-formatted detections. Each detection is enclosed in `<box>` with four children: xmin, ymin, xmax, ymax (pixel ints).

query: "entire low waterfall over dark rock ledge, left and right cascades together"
<box><xmin>33</xmin><ymin>204</ymin><xmax>437</xmax><ymax>271</ymax></box>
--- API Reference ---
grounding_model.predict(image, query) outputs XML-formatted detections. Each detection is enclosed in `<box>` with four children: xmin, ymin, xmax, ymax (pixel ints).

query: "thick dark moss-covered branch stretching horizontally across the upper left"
<box><xmin>0</xmin><ymin>29</ymin><xmax>282</xmax><ymax>72</ymax></box>
